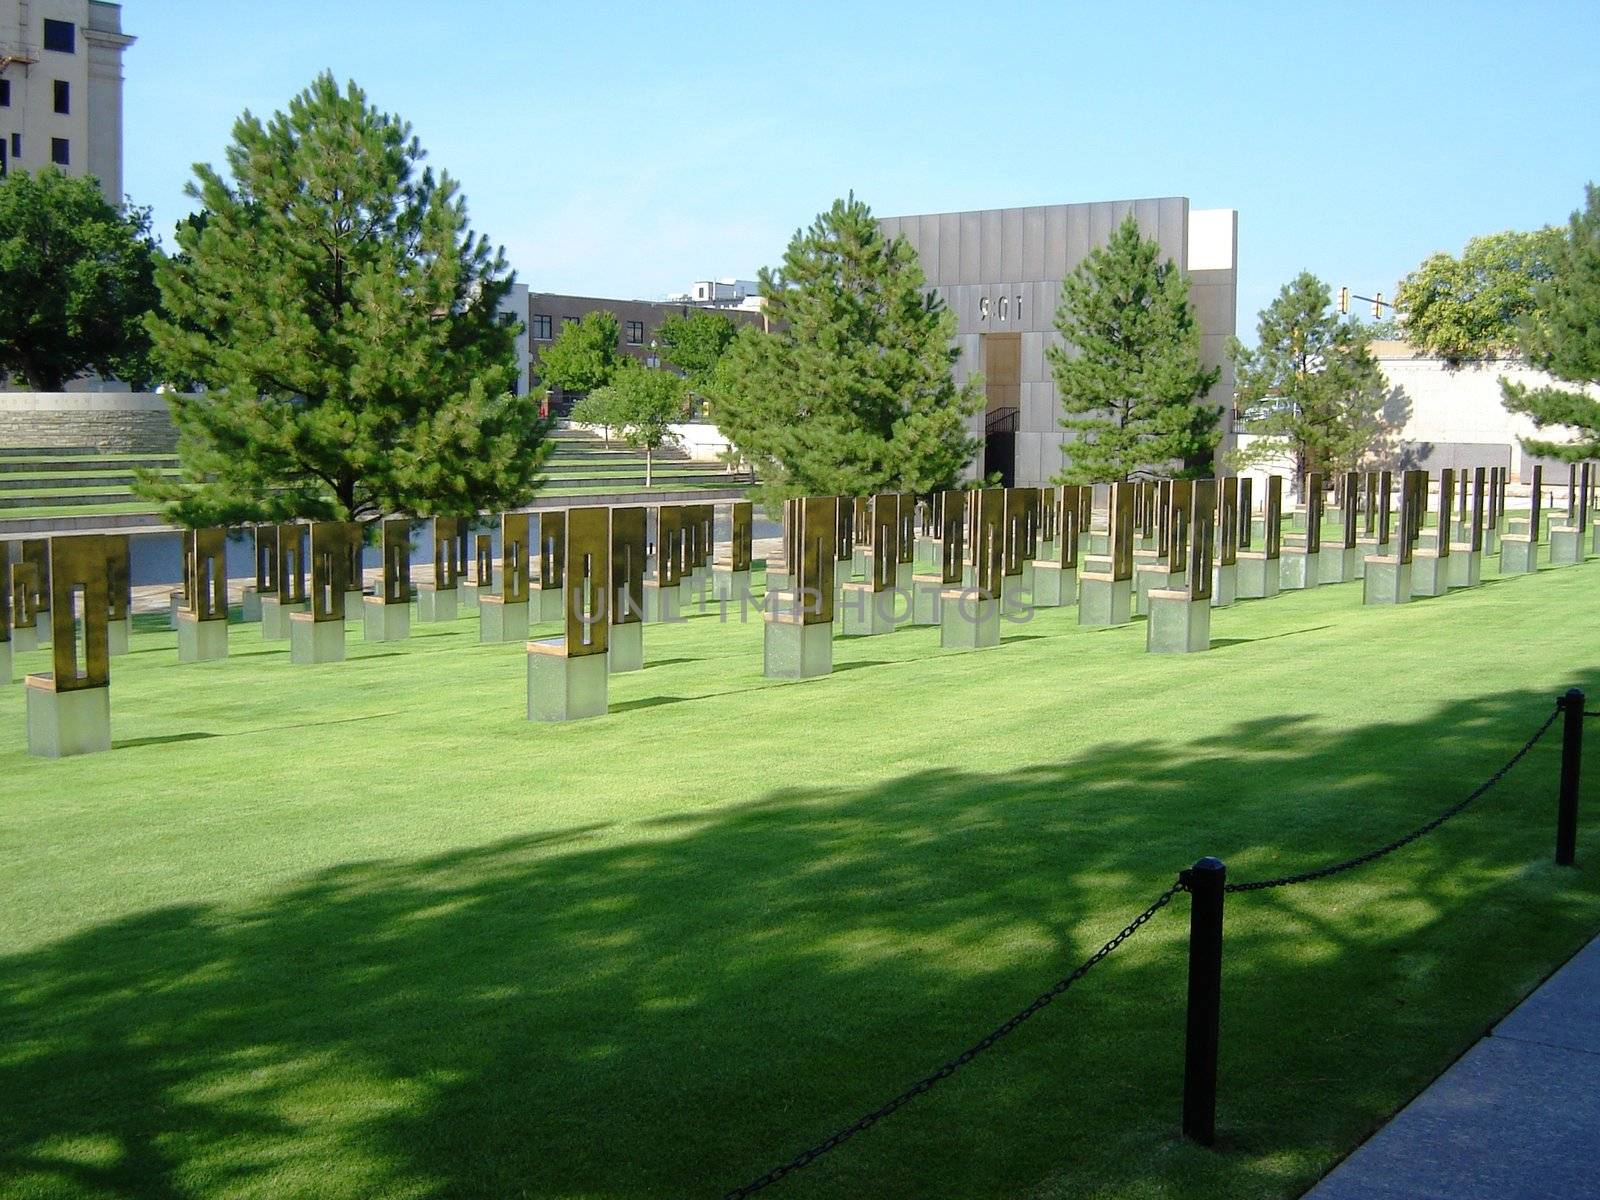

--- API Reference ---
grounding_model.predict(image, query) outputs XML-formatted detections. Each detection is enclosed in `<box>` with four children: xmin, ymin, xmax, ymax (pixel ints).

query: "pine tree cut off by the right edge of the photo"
<box><xmin>1501</xmin><ymin>184</ymin><xmax>1600</xmax><ymax>462</ymax></box>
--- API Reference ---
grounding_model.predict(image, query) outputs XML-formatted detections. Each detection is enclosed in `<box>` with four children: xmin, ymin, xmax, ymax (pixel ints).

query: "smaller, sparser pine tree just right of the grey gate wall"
<box><xmin>1232</xmin><ymin>270</ymin><xmax>1389</xmax><ymax>489</ymax></box>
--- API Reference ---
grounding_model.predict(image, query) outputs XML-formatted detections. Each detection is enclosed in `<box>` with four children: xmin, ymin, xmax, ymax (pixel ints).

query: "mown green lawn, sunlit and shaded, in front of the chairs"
<box><xmin>0</xmin><ymin>560</ymin><xmax>1600</xmax><ymax>1200</ymax></box>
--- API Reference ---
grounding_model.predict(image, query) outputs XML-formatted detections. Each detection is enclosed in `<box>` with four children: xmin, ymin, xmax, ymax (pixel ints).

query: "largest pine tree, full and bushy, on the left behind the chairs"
<box><xmin>141</xmin><ymin>74</ymin><xmax>549</xmax><ymax>525</ymax></box>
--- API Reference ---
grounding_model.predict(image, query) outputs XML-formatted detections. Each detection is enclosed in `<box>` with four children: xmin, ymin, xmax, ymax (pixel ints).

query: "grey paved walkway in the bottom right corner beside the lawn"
<box><xmin>1306</xmin><ymin>938</ymin><xmax>1600</xmax><ymax>1200</ymax></box>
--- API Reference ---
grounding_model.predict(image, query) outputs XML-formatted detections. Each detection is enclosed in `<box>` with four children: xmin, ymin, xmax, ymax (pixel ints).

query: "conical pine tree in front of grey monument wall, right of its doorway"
<box><xmin>1046</xmin><ymin>216</ymin><xmax>1221</xmax><ymax>483</ymax></box>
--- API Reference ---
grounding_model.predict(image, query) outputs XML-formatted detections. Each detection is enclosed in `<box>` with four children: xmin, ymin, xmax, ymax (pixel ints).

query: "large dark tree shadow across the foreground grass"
<box><xmin>0</xmin><ymin>672</ymin><xmax>1600</xmax><ymax>1200</ymax></box>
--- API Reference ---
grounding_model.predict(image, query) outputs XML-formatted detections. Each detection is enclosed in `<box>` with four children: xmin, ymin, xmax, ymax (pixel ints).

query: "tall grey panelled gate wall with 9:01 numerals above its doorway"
<box><xmin>880</xmin><ymin>197</ymin><xmax>1238</xmax><ymax>486</ymax></box>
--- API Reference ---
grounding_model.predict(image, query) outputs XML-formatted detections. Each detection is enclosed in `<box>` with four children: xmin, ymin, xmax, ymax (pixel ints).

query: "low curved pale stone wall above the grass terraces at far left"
<box><xmin>0</xmin><ymin>392</ymin><xmax>178</xmax><ymax>454</ymax></box>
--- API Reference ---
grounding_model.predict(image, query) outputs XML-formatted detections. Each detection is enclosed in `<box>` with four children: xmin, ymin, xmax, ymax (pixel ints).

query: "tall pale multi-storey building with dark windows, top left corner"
<box><xmin>0</xmin><ymin>0</ymin><xmax>133</xmax><ymax>205</ymax></box>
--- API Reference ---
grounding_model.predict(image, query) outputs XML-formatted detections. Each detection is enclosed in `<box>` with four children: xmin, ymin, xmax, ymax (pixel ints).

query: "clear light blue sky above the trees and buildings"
<box><xmin>123</xmin><ymin>0</ymin><xmax>1600</xmax><ymax>339</ymax></box>
